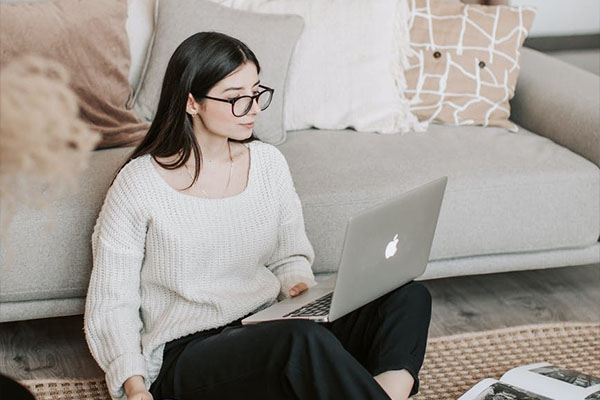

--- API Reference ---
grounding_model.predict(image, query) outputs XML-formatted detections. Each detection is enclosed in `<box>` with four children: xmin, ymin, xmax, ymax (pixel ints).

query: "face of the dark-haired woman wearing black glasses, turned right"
<box><xmin>191</xmin><ymin>62</ymin><xmax>260</xmax><ymax>140</ymax></box>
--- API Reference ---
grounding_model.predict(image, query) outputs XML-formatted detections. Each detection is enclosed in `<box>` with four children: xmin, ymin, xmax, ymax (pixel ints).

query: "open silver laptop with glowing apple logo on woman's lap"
<box><xmin>242</xmin><ymin>176</ymin><xmax>448</xmax><ymax>325</ymax></box>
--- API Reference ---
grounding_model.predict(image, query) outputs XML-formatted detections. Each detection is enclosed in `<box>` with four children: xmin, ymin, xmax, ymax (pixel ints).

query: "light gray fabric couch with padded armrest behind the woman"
<box><xmin>0</xmin><ymin>49</ymin><xmax>600</xmax><ymax>321</ymax></box>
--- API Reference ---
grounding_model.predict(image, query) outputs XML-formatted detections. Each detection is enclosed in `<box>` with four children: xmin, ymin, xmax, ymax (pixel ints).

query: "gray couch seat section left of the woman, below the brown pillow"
<box><xmin>0</xmin><ymin>147</ymin><xmax>133</xmax><ymax>302</ymax></box>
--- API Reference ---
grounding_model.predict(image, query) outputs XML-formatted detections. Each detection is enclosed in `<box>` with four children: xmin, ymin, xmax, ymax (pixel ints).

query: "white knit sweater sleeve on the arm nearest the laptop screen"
<box><xmin>267</xmin><ymin>151</ymin><xmax>317</xmax><ymax>299</ymax></box>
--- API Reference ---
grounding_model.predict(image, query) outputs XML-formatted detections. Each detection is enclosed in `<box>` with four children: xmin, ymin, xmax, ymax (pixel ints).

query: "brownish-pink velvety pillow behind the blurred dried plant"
<box><xmin>0</xmin><ymin>0</ymin><xmax>148</xmax><ymax>149</ymax></box>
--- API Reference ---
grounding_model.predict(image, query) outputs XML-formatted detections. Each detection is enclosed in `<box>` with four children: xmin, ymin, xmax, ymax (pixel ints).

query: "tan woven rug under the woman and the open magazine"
<box><xmin>21</xmin><ymin>323</ymin><xmax>600</xmax><ymax>400</ymax></box>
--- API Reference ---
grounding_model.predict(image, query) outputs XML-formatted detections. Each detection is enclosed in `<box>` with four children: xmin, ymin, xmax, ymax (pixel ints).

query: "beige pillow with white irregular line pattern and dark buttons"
<box><xmin>405</xmin><ymin>0</ymin><xmax>535</xmax><ymax>132</ymax></box>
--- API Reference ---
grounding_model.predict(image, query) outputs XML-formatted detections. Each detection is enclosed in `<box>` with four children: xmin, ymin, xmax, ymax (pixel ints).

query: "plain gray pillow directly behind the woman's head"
<box><xmin>133</xmin><ymin>0</ymin><xmax>304</xmax><ymax>144</ymax></box>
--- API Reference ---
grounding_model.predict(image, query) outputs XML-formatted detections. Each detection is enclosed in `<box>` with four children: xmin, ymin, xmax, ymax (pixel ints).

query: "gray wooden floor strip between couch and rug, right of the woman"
<box><xmin>425</xmin><ymin>264</ymin><xmax>600</xmax><ymax>337</ymax></box>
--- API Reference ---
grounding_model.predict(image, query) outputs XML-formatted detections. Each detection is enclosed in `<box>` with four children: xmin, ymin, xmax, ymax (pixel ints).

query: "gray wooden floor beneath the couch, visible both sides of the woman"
<box><xmin>0</xmin><ymin>264</ymin><xmax>600</xmax><ymax>380</ymax></box>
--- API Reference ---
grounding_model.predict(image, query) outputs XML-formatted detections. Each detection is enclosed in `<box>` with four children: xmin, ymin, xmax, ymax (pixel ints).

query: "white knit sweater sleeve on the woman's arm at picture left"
<box><xmin>84</xmin><ymin>166</ymin><xmax>149</xmax><ymax>399</ymax></box>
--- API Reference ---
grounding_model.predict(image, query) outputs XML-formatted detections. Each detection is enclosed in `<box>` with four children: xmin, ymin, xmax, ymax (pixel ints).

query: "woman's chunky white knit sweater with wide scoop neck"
<box><xmin>84</xmin><ymin>141</ymin><xmax>316</xmax><ymax>399</ymax></box>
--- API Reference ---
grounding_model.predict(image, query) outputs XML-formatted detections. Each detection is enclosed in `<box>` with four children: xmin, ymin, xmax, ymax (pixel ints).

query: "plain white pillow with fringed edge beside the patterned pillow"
<box><xmin>227</xmin><ymin>0</ymin><xmax>427</xmax><ymax>133</ymax></box>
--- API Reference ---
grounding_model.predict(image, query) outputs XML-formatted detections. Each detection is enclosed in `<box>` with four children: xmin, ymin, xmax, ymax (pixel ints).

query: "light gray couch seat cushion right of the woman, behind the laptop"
<box><xmin>278</xmin><ymin>124</ymin><xmax>600</xmax><ymax>272</ymax></box>
